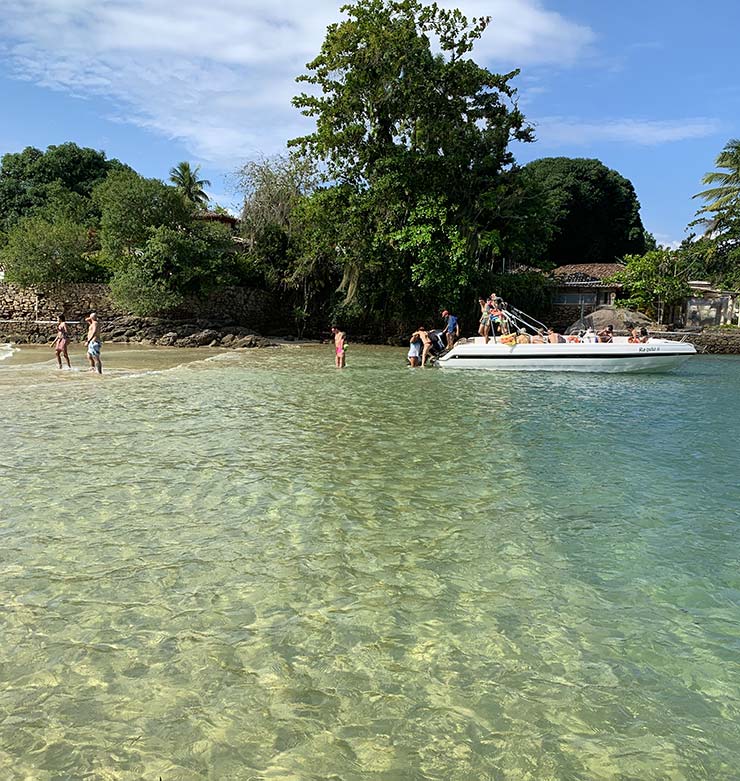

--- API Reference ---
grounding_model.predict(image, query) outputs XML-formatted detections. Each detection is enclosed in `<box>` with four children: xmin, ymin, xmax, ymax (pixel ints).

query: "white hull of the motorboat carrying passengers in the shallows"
<box><xmin>438</xmin><ymin>336</ymin><xmax>696</xmax><ymax>372</ymax></box>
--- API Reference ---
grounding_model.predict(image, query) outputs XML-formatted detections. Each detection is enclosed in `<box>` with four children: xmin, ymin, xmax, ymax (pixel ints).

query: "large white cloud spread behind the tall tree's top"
<box><xmin>0</xmin><ymin>0</ymin><xmax>594</xmax><ymax>168</ymax></box>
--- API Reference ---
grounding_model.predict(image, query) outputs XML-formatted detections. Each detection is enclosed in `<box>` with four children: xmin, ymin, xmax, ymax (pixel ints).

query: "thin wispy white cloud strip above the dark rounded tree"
<box><xmin>536</xmin><ymin>117</ymin><xmax>721</xmax><ymax>147</ymax></box>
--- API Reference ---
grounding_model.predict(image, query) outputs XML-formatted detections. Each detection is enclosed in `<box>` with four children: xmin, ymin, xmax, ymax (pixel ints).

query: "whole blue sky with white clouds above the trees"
<box><xmin>0</xmin><ymin>0</ymin><xmax>740</xmax><ymax>244</ymax></box>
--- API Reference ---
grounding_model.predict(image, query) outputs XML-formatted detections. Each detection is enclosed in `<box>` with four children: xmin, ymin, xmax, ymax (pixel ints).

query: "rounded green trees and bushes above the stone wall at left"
<box><xmin>0</xmin><ymin>144</ymin><xmax>244</xmax><ymax>314</ymax></box>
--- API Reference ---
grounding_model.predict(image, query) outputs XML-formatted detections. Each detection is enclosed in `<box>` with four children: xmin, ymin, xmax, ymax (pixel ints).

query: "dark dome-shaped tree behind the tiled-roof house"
<box><xmin>524</xmin><ymin>157</ymin><xmax>647</xmax><ymax>266</ymax></box>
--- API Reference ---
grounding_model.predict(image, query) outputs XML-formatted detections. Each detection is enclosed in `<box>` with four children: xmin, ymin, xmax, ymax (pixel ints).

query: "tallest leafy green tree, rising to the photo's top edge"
<box><xmin>290</xmin><ymin>0</ymin><xmax>532</xmax><ymax>320</ymax></box>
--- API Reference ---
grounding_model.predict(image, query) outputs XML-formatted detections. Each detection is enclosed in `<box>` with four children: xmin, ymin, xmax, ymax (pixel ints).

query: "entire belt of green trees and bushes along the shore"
<box><xmin>7</xmin><ymin>0</ymin><xmax>728</xmax><ymax>336</ymax></box>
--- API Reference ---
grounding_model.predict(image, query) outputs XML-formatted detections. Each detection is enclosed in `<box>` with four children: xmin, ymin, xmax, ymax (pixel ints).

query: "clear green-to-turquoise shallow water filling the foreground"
<box><xmin>0</xmin><ymin>346</ymin><xmax>740</xmax><ymax>781</ymax></box>
